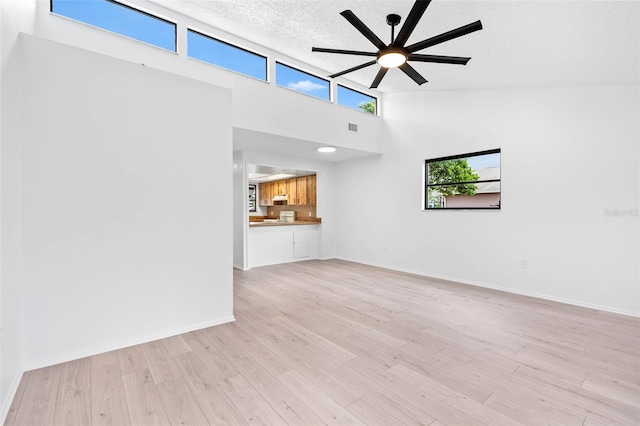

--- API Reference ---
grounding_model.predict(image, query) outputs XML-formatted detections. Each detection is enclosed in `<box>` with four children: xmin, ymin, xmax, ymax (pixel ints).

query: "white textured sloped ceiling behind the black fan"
<box><xmin>152</xmin><ymin>0</ymin><xmax>640</xmax><ymax>92</ymax></box>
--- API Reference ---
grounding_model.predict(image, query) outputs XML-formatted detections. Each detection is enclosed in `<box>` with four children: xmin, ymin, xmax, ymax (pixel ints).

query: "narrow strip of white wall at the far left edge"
<box><xmin>0</xmin><ymin>0</ymin><xmax>35</xmax><ymax>421</ymax></box>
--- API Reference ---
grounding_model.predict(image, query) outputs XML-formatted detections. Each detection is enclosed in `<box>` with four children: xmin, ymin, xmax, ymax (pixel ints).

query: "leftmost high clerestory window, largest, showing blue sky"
<box><xmin>51</xmin><ymin>0</ymin><xmax>176</xmax><ymax>52</ymax></box>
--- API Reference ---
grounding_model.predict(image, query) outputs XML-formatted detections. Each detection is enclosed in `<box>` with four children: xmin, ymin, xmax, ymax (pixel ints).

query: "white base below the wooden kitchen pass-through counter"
<box><xmin>248</xmin><ymin>225</ymin><xmax>320</xmax><ymax>268</ymax></box>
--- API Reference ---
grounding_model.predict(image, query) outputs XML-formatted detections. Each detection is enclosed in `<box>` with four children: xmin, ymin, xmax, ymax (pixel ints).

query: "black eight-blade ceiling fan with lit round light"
<box><xmin>311</xmin><ymin>0</ymin><xmax>482</xmax><ymax>89</ymax></box>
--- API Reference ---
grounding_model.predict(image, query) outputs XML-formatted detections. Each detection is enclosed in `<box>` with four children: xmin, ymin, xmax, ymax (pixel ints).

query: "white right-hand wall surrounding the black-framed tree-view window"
<box><xmin>334</xmin><ymin>85</ymin><xmax>640</xmax><ymax>315</ymax></box>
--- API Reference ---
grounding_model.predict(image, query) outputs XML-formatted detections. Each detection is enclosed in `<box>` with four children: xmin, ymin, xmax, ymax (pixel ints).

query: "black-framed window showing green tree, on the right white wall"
<box><xmin>424</xmin><ymin>149</ymin><xmax>501</xmax><ymax>210</ymax></box>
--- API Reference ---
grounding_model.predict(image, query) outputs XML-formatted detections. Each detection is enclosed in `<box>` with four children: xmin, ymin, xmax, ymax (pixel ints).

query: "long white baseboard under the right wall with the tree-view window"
<box><xmin>336</xmin><ymin>257</ymin><xmax>640</xmax><ymax>318</ymax></box>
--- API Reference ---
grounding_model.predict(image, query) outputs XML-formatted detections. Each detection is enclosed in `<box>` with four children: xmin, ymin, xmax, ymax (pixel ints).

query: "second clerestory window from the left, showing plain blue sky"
<box><xmin>187</xmin><ymin>30</ymin><xmax>267</xmax><ymax>81</ymax></box>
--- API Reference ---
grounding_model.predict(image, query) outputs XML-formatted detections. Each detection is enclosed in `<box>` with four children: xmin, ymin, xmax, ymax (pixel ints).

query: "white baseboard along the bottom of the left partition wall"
<box><xmin>23</xmin><ymin>315</ymin><xmax>236</xmax><ymax>371</ymax></box>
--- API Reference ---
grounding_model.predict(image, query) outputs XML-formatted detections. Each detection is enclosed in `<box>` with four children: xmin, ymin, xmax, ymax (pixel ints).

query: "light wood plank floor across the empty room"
<box><xmin>5</xmin><ymin>261</ymin><xmax>640</xmax><ymax>426</ymax></box>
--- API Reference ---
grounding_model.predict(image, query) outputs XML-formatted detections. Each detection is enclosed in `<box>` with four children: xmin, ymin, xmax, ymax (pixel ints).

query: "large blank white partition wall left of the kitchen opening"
<box><xmin>20</xmin><ymin>35</ymin><xmax>233</xmax><ymax>370</ymax></box>
